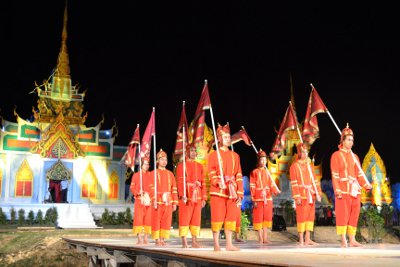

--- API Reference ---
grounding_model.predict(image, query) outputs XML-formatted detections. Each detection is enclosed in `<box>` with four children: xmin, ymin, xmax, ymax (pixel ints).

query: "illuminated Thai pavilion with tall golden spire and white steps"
<box><xmin>0</xmin><ymin>5</ymin><xmax>128</xmax><ymax>227</ymax></box>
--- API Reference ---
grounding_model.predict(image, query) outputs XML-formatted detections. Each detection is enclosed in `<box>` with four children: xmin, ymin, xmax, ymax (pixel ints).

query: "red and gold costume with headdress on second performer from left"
<box><xmin>151</xmin><ymin>150</ymin><xmax>178</xmax><ymax>239</ymax></box>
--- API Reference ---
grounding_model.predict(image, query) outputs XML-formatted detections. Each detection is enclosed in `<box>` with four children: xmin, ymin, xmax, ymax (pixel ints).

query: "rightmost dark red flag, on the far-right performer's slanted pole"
<box><xmin>302</xmin><ymin>84</ymin><xmax>328</xmax><ymax>145</ymax></box>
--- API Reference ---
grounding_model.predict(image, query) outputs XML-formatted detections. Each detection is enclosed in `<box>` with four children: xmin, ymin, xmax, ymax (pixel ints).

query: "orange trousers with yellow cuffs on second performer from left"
<box><xmin>151</xmin><ymin>204</ymin><xmax>172</xmax><ymax>239</ymax></box>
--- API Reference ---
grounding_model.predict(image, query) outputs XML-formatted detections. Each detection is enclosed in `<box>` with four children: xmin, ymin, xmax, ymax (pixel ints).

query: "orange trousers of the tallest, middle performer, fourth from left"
<box><xmin>210</xmin><ymin>195</ymin><xmax>240</xmax><ymax>232</ymax></box>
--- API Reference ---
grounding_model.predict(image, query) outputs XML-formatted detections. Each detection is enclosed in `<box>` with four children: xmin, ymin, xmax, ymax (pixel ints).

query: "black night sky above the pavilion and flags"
<box><xmin>0</xmin><ymin>0</ymin><xmax>400</xmax><ymax>183</ymax></box>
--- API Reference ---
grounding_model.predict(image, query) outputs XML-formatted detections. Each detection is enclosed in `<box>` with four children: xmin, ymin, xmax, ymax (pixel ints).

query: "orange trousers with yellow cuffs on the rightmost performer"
<box><xmin>335</xmin><ymin>194</ymin><xmax>361</xmax><ymax>235</ymax></box>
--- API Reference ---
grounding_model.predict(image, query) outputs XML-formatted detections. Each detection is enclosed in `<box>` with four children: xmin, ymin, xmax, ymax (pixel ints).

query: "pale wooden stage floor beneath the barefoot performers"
<box><xmin>64</xmin><ymin>237</ymin><xmax>400</xmax><ymax>267</ymax></box>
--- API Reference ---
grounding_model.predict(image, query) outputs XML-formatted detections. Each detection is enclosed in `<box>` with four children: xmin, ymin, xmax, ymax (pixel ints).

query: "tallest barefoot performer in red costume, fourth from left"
<box><xmin>208</xmin><ymin>125</ymin><xmax>243</xmax><ymax>251</ymax></box>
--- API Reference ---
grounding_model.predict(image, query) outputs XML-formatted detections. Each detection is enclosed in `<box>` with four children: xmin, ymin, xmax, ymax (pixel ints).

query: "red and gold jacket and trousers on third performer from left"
<box><xmin>176</xmin><ymin>160</ymin><xmax>207</xmax><ymax>237</ymax></box>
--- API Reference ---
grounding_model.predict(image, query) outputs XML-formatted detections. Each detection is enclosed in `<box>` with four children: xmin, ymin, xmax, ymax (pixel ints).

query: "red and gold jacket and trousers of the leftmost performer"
<box><xmin>130</xmin><ymin>168</ymin><xmax>154</xmax><ymax>237</ymax></box>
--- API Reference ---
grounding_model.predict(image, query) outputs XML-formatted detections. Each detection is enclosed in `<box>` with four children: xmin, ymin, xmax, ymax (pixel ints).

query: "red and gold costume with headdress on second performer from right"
<box><xmin>290</xmin><ymin>143</ymin><xmax>321</xmax><ymax>233</ymax></box>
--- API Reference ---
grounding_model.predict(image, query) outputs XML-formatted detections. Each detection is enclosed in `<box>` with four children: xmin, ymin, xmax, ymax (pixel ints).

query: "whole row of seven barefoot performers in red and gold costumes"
<box><xmin>130</xmin><ymin>125</ymin><xmax>370</xmax><ymax>251</ymax></box>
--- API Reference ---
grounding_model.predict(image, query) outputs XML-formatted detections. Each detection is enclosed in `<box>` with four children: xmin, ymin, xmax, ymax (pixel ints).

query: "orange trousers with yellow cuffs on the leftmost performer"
<box><xmin>133</xmin><ymin>199</ymin><xmax>152</xmax><ymax>234</ymax></box>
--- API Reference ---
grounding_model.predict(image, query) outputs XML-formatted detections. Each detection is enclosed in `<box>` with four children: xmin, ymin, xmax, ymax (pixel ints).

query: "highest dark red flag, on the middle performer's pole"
<box><xmin>192</xmin><ymin>80</ymin><xmax>211</xmax><ymax>143</ymax></box>
